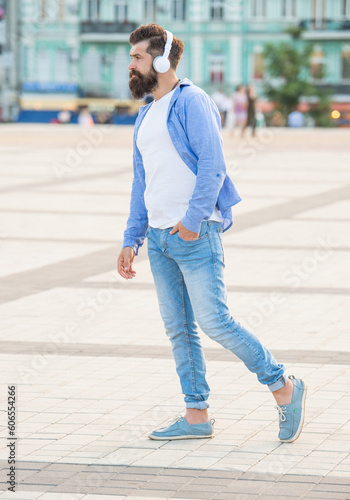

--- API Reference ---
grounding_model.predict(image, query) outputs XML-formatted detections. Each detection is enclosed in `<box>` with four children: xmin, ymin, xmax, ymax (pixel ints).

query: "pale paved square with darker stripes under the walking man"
<box><xmin>0</xmin><ymin>125</ymin><xmax>350</xmax><ymax>500</ymax></box>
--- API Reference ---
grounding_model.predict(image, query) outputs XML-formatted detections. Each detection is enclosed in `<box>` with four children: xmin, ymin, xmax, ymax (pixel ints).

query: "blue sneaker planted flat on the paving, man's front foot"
<box><xmin>148</xmin><ymin>415</ymin><xmax>215</xmax><ymax>441</ymax></box>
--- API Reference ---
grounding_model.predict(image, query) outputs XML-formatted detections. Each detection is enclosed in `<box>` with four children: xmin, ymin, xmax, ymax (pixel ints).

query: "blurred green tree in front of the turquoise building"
<box><xmin>264</xmin><ymin>37</ymin><xmax>332</xmax><ymax>126</ymax></box>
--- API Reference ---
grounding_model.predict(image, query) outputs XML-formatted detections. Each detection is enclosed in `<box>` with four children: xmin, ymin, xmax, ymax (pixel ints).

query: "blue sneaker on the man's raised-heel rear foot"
<box><xmin>276</xmin><ymin>375</ymin><xmax>307</xmax><ymax>443</ymax></box>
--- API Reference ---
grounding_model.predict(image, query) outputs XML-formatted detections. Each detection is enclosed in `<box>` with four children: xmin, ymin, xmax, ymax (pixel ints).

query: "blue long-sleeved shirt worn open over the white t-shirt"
<box><xmin>123</xmin><ymin>78</ymin><xmax>241</xmax><ymax>255</ymax></box>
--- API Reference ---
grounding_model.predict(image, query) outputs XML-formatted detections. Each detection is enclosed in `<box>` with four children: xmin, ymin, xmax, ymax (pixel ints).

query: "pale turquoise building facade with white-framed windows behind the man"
<box><xmin>16</xmin><ymin>0</ymin><xmax>350</xmax><ymax>118</ymax></box>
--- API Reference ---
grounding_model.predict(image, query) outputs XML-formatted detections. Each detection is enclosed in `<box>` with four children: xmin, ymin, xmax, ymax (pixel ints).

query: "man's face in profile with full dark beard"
<box><xmin>128</xmin><ymin>40</ymin><xmax>158</xmax><ymax>99</ymax></box>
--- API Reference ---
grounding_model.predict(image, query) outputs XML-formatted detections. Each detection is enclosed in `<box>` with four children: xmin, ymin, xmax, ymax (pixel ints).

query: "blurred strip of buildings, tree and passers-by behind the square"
<box><xmin>0</xmin><ymin>0</ymin><xmax>350</xmax><ymax>127</ymax></box>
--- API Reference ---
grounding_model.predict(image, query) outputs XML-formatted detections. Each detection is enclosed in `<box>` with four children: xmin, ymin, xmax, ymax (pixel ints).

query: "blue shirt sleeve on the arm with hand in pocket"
<box><xmin>181</xmin><ymin>93</ymin><xmax>226</xmax><ymax>233</ymax></box>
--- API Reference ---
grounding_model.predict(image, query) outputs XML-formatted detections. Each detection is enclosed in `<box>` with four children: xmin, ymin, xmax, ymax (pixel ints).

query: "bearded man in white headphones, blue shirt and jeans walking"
<box><xmin>118</xmin><ymin>24</ymin><xmax>306</xmax><ymax>442</ymax></box>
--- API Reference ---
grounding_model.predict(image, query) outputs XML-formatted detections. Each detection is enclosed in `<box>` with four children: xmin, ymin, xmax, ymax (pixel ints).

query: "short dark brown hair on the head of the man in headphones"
<box><xmin>129</xmin><ymin>24</ymin><xmax>184</xmax><ymax>69</ymax></box>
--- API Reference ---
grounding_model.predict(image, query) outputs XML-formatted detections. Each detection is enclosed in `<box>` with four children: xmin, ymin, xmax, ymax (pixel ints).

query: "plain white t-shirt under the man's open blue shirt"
<box><xmin>137</xmin><ymin>90</ymin><xmax>222</xmax><ymax>229</ymax></box>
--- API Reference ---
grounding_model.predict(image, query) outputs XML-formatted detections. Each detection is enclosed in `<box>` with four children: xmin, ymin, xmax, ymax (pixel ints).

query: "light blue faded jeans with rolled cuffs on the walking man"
<box><xmin>147</xmin><ymin>221</ymin><xmax>286</xmax><ymax>409</ymax></box>
